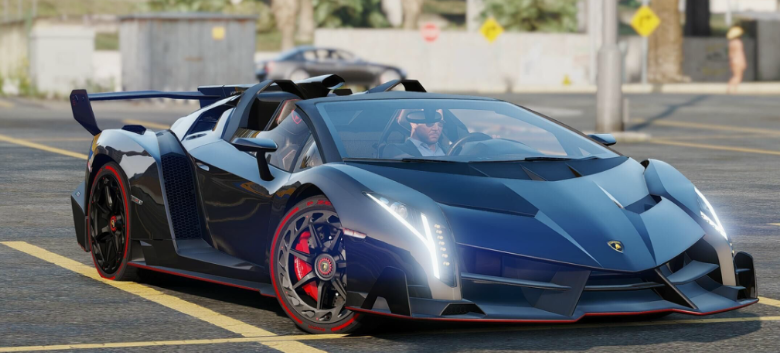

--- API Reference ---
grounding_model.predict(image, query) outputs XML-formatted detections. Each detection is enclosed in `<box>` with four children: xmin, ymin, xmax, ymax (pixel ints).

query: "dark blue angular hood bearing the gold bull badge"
<box><xmin>348</xmin><ymin>157</ymin><xmax>704</xmax><ymax>271</ymax></box>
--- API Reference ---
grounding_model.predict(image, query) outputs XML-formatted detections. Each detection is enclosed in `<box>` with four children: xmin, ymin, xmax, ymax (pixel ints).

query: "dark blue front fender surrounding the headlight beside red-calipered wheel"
<box><xmin>280</xmin><ymin>163</ymin><xmax>462</xmax><ymax>306</ymax></box>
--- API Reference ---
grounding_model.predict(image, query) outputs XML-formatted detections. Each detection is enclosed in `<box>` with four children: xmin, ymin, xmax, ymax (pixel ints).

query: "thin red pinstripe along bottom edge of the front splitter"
<box><xmin>347</xmin><ymin>299</ymin><xmax>758</xmax><ymax>324</ymax></box>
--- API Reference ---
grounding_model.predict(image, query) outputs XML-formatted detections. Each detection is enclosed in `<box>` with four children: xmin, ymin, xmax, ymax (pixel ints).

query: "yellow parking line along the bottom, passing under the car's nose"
<box><xmin>0</xmin><ymin>314</ymin><xmax>780</xmax><ymax>353</ymax></box>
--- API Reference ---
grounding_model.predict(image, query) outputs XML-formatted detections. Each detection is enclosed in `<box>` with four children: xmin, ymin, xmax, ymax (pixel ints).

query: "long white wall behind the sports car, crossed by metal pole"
<box><xmin>314</xmin><ymin>29</ymin><xmax>641</xmax><ymax>92</ymax></box>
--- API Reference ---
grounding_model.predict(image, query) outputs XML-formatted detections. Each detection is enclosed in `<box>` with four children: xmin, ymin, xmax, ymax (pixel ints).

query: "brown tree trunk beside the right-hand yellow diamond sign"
<box><xmin>647</xmin><ymin>0</ymin><xmax>689</xmax><ymax>83</ymax></box>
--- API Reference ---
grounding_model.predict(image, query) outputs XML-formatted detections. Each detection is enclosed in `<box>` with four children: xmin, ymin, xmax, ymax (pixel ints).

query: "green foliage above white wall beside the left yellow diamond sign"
<box><xmin>482</xmin><ymin>0</ymin><xmax>577</xmax><ymax>32</ymax></box>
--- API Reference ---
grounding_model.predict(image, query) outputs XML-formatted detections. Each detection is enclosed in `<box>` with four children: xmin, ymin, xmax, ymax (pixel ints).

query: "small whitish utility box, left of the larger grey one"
<box><xmin>29</xmin><ymin>25</ymin><xmax>95</xmax><ymax>96</ymax></box>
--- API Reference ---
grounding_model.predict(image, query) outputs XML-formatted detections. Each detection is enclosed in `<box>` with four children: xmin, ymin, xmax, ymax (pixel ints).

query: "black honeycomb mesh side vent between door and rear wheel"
<box><xmin>162</xmin><ymin>153</ymin><xmax>201</xmax><ymax>239</ymax></box>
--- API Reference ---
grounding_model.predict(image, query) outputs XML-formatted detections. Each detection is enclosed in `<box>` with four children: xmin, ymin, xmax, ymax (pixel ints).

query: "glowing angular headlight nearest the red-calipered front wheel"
<box><xmin>366</xmin><ymin>193</ymin><xmax>442</xmax><ymax>279</ymax></box>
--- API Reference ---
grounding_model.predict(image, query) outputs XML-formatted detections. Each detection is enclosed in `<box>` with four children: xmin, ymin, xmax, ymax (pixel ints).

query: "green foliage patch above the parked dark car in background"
<box><xmin>312</xmin><ymin>0</ymin><xmax>390</xmax><ymax>28</ymax></box>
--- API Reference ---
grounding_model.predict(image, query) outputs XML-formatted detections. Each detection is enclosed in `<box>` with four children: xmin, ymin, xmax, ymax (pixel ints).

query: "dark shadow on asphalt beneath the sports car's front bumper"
<box><xmin>362</xmin><ymin>313</ymin><xmax>761</xmax><ymax>351</ymax></box>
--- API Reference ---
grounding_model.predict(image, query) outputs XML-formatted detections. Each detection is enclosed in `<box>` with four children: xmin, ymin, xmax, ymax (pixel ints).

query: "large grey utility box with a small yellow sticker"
<box><xmin>119</xmin><ymin>13</ymin><xmax>256</xmax><ymax>91</ymax></box>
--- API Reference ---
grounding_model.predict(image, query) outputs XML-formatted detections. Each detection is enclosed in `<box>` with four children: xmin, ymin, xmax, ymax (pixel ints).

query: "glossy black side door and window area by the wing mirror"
<box><xmin>191</xmin><ymin>102</ymin><xmax>311</xmax><ymax>264</ymax></box>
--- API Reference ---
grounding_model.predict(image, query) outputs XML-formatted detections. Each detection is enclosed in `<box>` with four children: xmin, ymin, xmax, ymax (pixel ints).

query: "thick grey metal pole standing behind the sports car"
<box><xmin>596</xmin><ymin>0</ymin><xmax>623</xmax><ymax>133</ymax></box>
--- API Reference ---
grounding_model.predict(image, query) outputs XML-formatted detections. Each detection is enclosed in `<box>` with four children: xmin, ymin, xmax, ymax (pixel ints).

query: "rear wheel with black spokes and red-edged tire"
<box><xmin>87</xmin><ymin>162</ymin><xmax>138</xmax><ymax>281</ymax></box>
